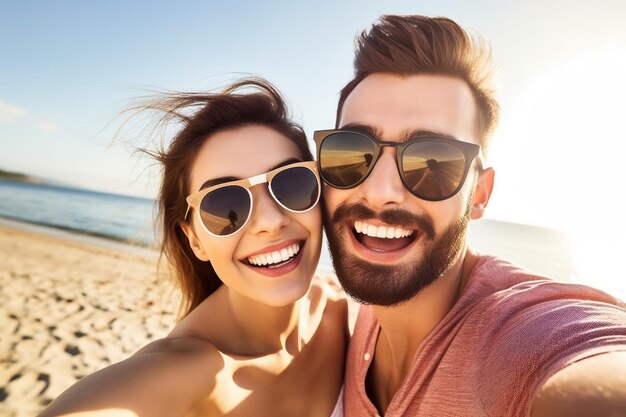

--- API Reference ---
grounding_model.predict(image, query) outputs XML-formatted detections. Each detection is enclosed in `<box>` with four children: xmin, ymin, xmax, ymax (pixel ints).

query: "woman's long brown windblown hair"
<box><xmin>129</xmin><ymin>78</ymin><xmax>313</xmax><ymax>318</ymax></box>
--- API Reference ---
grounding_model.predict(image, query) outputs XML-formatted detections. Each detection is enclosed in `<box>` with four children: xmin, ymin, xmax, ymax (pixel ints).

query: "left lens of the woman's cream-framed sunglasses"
<box><xmin>200</xmin><ymin>186</ymin><xmax>250</xmax><ymax>236</ymax></box>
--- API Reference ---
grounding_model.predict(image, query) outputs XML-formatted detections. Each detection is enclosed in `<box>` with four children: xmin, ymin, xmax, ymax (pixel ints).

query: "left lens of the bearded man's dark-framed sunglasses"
<box><xmin>319</xmin><ymin>132</ymin><xmax>376</xmax><ymax>188</ymax></box>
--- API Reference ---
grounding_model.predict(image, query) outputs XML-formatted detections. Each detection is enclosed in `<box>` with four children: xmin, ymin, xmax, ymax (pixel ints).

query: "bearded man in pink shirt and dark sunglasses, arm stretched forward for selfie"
<box><xmin>315</xmin><ymin>16</ymin><xmax>626</xmax><ymax>417</ymax></box>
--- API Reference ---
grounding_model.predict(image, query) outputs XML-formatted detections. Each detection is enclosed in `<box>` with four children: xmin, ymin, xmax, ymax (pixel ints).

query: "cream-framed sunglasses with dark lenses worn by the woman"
<box><xmin>185</xmin><ymin>161</ymin><xmax>320</xmax><ymax>236</ymax></box>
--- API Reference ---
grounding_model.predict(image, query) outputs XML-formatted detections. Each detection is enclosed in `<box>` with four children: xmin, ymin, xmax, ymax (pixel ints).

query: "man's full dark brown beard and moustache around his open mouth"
<box><xmin>324</xmin><ymin>200</ymin><xmax>471</xmax><ymax>306</ymax></box>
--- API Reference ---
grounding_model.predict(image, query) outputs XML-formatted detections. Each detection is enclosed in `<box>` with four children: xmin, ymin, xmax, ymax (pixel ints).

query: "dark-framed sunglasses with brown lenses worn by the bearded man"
<box><xmin>314</xmin><ymin>130</ymin><xmax>482</xmax><ymax>201</ymax></box>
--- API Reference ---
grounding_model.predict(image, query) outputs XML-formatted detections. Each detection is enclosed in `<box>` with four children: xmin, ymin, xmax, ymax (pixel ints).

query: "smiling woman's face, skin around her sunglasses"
<box><xmin>183</xmin><ymin>125</ymin><xmax>322</xmax><ymax>306</ymax></box>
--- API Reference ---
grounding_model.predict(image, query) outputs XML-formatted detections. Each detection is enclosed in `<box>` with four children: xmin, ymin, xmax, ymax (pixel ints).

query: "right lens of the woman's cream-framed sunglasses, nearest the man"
<box><xmin>270</xmin><ymin>167</ymin><xmax>320</xmax><ymax>211</ymax></box>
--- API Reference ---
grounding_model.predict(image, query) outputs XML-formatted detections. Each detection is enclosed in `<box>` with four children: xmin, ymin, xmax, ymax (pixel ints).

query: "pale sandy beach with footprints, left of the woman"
<box><xmin>0</xmin><ymin>224</ymin><xmax>179</xmax><ymax>417</ymax></box>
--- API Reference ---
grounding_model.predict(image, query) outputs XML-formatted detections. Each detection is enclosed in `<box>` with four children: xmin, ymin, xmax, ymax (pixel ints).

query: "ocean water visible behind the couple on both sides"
<box><xmin>0</xmin><ymin>180</ymin><xmax>576</xmax><ymax>280</ymax></box>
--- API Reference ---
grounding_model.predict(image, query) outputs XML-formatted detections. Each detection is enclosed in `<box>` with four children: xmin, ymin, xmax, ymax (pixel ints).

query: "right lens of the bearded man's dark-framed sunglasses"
<box><xmin>402</xmin><ymin>141</ymin><xmax>465</xmax><ymax>200</ymax></box>
